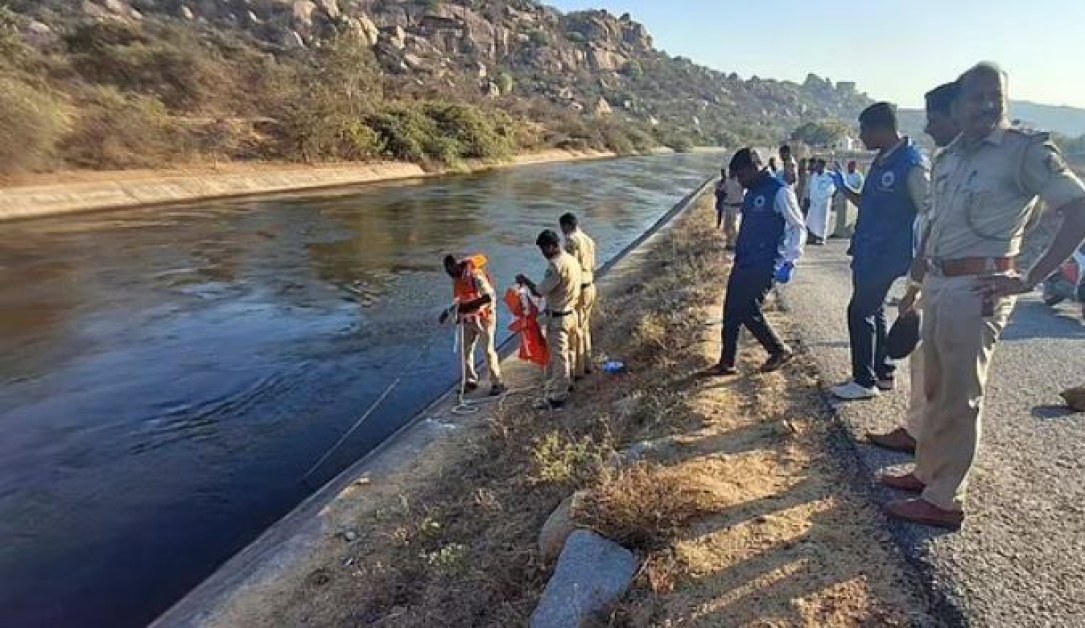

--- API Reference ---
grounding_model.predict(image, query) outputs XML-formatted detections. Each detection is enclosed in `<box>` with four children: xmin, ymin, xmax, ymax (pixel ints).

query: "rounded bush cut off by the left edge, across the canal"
<box><xmin>0</xmin><ymin>76</ymin><xmax>71</xmax><ymax>172</ymax></box>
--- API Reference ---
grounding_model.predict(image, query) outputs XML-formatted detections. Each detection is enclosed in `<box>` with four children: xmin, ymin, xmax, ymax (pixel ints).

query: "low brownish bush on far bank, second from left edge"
<box><xmin>62</xmin><ymin>87</ymin><xmax>178</xmax><ymax>169</ymax></box>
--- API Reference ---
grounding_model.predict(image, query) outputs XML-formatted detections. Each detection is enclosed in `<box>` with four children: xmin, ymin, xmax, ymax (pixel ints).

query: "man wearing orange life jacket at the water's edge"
<box><xmin>439</xmin><ymin>255</ymin><xmax>505</xmax><ymax>396</ymax></box>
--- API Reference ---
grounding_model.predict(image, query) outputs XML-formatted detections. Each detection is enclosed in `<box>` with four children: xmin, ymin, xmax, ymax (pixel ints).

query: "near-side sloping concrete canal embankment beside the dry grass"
<box><xmin>154</xmin><ymin>174</ymin><xmax>711</xmax><ymax>627</ymax></box>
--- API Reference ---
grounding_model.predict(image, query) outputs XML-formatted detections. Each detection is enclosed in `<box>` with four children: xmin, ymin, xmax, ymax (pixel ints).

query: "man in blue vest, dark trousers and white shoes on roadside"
<box><xmin>830</xmin><ymin>102</ymin><xmax>930</xmax><ymax>400</ymax></box>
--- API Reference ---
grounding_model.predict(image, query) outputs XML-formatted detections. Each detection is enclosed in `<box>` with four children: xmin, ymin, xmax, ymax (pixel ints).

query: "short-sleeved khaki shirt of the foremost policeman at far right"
<box><xmin>926</xmin><ymin>128</ymin><xmax>1085</xmax><ymax>259</ymax></box>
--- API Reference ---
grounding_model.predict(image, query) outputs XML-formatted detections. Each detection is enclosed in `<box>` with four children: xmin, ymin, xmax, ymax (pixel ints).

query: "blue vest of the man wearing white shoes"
<box><xmin>852</xmin><ymin>140</ymin><xmax>927</xmax><ymax>275</ymax></box>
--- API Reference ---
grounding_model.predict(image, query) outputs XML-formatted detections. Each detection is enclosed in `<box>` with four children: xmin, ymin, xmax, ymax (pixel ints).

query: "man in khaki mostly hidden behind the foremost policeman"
<box><xmin>868</xmin><ymin>81</ymin><xmax>960</xmax><ymax>453</ymax></box>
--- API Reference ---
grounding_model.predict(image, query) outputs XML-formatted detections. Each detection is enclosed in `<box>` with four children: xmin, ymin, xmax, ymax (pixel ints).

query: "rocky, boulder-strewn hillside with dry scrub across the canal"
<box><xmin>0</xmin><ymin>0</ymin><xmax>870</xmax><ymax>172</ymax></box>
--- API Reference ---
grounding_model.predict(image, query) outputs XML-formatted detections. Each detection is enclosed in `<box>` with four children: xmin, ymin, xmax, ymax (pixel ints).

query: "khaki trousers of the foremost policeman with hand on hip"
<box><xmin>915</xmin><ymin>273</ymin><xmax>1014</xmax><ymax>511</ymax></box>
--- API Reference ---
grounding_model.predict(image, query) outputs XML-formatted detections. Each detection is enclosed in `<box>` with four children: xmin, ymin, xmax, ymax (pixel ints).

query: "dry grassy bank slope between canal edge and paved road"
<box><xmin>218</xmin><ymin>194</ymin><xmax>928</xmax><ymax>627</ymax></box>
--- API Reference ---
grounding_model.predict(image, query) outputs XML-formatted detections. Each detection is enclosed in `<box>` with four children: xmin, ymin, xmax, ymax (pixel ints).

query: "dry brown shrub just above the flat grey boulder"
<box><xmin>575</xmin><ymin>463</ymin><xmax>729</xmax><ymax>551</ymax></box>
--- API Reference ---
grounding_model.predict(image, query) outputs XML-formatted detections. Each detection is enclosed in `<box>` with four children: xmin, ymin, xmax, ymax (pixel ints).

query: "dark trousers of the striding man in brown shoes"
<box><xmin>719</xmin><ymin>265</ymin><xmax>786</xmax><ymax>367</ymax></box>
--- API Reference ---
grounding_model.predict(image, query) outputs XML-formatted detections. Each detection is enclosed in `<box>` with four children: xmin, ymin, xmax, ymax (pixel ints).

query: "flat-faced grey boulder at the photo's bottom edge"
<box><xmin>531</xmin><ymin>530</ymin><xmax>638</xmax><ymax>628</ymax></box>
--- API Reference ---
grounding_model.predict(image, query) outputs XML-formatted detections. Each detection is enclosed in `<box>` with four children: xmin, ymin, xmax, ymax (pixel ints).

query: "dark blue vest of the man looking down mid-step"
<box><xmin>735</xmin><ymin>172</ymin><xmax>787</xmax><ymax>268</ymax></box>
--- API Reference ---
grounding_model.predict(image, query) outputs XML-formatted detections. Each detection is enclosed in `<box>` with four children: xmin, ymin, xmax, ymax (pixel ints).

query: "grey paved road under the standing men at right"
<box><xmin>782</xmin><ymin>242</ymin><xmax>1085</xmax><ymax>627</ymax></box>
